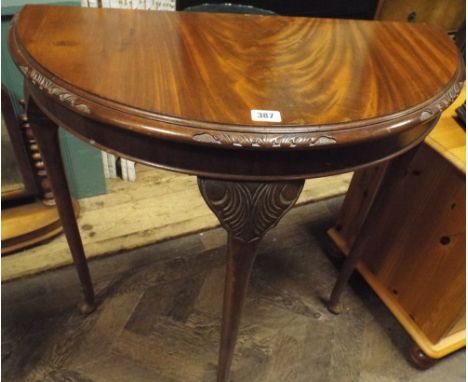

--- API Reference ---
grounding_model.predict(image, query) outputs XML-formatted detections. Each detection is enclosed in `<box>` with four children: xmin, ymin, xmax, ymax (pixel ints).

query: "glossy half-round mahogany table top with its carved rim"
<box><xmin>10</xmin><ymin>5</ymin><xmax>464</xmax><ymax>150</ymax></box>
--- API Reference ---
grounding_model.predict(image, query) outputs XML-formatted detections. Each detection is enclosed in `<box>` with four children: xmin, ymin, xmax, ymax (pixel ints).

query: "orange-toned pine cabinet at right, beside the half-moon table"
<box><xmin>329</xmin><ymin>87</ymin><xmax>466</xmax><ymax>362</ymax></box>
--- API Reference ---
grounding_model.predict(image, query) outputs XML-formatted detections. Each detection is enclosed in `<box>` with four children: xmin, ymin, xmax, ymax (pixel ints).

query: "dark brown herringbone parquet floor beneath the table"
<box><xmin>2</xmin><ymin>198</ymin><xmax>465</xmax><ymax>382</ymax></box>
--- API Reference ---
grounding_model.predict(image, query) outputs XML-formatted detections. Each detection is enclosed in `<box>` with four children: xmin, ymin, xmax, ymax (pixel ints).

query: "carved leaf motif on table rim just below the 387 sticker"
<box><xmin>192</xmin><ymin>133</ymin><xmax>336</xmax><ymax>148</ymax></box>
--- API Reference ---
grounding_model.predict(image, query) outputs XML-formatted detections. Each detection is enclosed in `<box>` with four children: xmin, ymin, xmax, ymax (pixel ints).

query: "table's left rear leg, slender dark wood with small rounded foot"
<box><xmin>27</xmin><ymin>97</ymin><xmax>95</xmax><ymax>314</ymax></box>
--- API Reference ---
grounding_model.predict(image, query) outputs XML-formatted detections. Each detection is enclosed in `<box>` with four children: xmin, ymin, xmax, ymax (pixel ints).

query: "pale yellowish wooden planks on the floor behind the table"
<box><xmin>2</xmin><ymin>165</ymin><xmax>352</xmax><ymax>281</ymax></box>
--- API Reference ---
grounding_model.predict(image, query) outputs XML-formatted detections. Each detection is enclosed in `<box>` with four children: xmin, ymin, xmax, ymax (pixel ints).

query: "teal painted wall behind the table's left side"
<box><xmin>2</xmin><ymin>0</ymin><xmax>106</xmax><ymax>198</ymax></box>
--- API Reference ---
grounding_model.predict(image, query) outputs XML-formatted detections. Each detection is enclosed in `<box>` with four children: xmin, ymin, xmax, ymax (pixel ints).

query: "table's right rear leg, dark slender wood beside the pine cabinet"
<box><xmin>327</xmin><ymin>145</ymin><xmax>419</xmax><ymax>314</ymax></box>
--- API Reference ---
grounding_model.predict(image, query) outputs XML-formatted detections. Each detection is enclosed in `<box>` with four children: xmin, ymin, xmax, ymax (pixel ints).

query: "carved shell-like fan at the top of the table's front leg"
<box><xmin>198</xmin><ymin>178</ymin><xmax>304</xmax><ymax>242</ymax></box>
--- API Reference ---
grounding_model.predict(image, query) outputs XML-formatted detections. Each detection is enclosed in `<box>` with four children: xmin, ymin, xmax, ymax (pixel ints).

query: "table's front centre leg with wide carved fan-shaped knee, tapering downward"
<box><xmin>198</xmin><ymin>178</ymin><xmax>304</xmax><ymax>382</ymax></box>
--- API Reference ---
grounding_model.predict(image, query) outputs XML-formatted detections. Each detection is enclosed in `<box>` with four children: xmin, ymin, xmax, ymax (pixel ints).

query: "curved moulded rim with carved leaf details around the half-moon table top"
<box><xmin>9</xmin><ymin>14</ymin><xmax>465</xmax><ymax>150</ymax></box>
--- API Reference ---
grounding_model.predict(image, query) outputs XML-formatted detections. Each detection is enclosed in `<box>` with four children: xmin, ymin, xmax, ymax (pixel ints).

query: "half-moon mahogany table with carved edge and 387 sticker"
<box><xmin>9</xmin><ymin>6</ymin><xmax>464</xmax><ymax>382</ymax></box>
